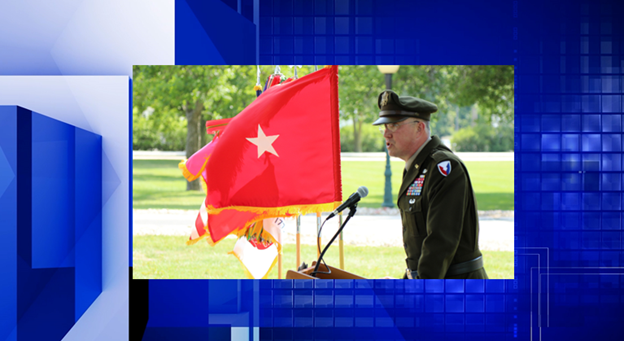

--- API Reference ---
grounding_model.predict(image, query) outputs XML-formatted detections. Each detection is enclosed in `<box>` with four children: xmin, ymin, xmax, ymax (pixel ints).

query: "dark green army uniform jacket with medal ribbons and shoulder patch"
<box><xmin>397</xmin><ymin>136</ymin><xmax>487</xmax><ymax>279</ymax></box>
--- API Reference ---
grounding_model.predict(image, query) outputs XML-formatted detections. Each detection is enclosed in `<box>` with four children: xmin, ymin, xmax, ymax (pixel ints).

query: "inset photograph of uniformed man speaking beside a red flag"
<box><xmin>132</xmin><ymin>65</ymin><xmax>514</xmax><ymax>280</ymax></box>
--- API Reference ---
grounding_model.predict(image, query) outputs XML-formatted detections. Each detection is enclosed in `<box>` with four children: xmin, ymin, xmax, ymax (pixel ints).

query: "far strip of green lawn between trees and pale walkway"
<box><xmin>132</xmin><ymin>160</ymin><xmax>514</xmax><ymax>210</ymax></box>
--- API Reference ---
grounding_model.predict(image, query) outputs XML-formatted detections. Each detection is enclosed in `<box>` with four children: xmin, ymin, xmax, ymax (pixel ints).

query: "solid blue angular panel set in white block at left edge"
<box><xmin>0</xmin><ymin>106</ymin><xmax>102</xmax><ymax>340</ymax></box>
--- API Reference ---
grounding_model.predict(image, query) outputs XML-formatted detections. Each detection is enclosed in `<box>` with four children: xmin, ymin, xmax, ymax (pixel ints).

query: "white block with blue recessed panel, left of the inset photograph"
<box><xmin>0</xmin><ymin>76</ymin><xmax>130</xmax><ymax>340</ymax></box>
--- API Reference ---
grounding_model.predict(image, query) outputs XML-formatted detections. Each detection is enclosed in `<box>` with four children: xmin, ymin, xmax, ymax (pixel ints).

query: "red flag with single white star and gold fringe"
<box><xmin>205</xmin><ymin>66</ymin><xmax>342</xmax><ymax>243</ymax></box>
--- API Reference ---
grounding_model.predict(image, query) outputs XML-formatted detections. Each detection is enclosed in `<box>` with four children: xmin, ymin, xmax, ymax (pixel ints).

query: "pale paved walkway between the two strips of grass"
<box><xmin>133</xmin><ymin>208</ymin><xmax>514</xmax><ymax>251</ymax></box>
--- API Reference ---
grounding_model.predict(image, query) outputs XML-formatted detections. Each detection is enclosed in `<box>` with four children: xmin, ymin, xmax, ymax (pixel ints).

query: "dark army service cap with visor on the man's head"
<box><xmin>373</xmin><ymin>90</ymin><xmax>438</xmax><ymax>125</ymax></box>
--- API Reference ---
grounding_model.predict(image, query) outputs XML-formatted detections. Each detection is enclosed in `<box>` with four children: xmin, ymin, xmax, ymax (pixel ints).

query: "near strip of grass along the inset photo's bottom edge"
<box><xmin>133</xmin><ymin>236</ymin><xmax>514</xmax><ymax>279</ymax></box>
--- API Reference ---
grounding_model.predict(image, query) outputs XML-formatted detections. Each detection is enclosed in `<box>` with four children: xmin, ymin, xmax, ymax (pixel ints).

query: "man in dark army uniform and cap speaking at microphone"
<box><xmin>373</xmin><ymin>90</ymin><xmax>488</xmax><ymax>279</ymax></box>
